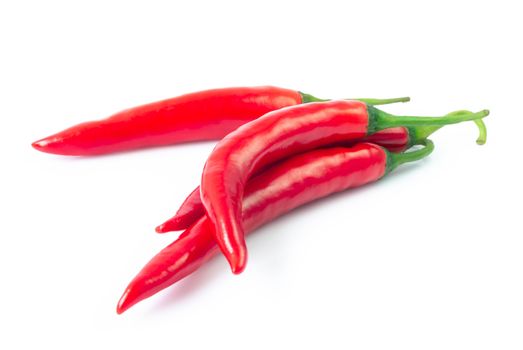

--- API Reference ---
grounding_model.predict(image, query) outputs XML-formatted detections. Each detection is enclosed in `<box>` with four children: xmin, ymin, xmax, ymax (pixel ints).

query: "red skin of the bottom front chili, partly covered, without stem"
<box><xmin>117</xmin><ymin>143</ymin><xmax>387</xmax><ymax>313</ymax></box>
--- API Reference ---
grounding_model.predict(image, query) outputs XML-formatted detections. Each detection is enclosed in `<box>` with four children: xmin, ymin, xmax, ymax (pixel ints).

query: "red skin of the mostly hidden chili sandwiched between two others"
<box><xmin>156</xmin><ymin>126</ymin><xmax>410</xmax><ymax>233</ymax></box>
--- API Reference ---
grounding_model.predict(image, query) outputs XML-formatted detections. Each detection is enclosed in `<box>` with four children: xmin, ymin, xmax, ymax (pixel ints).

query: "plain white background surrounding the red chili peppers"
<box><xmin>0</xmin><ymin>0</ymin><xmax>523</xmax><ymax>350</ymax></box>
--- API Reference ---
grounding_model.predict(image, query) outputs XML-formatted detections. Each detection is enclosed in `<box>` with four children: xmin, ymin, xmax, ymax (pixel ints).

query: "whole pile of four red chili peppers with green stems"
<box><xmin>33</xmin><ymin>86</ymin><xmax>489</xmax><ymax>313</ymax></box>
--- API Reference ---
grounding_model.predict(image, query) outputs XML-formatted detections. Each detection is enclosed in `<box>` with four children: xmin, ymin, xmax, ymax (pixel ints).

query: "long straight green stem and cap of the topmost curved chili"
<box><xmin>368</xmin><ymin>106</ymin><xmax>489</xmax><ymax>134</ymax></box>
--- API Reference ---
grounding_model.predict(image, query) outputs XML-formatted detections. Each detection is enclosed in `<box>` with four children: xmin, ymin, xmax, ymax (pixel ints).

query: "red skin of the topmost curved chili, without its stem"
<box><xmin>200</xmin><ymin>100</ymin><xmax>369</xmax><ymax>274</ymax></box>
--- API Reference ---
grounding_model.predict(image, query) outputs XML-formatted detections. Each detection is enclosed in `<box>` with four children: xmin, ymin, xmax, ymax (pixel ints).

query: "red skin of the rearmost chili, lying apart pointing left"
<box><xmin>33</xmin><ymin>86</ymin><xmax>302</xmax><ymax>156</ymax></box>
